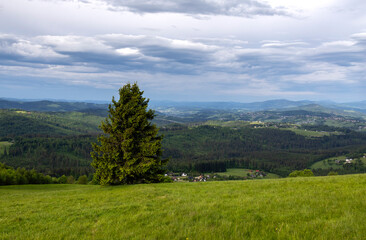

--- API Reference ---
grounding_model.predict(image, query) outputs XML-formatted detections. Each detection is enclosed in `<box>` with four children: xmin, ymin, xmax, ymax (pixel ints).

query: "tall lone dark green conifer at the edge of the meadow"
<box><xmin>91</xmin><ymin>83</ymin><xmax>168</xmax><ymax>185</ymax></box>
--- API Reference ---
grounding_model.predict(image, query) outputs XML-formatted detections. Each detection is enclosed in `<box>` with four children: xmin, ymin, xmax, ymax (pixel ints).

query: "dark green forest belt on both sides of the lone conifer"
<box><xmin>0</xmin><ymin>125</ymin><xmax>366</xmax><ymax>177</ymax></box>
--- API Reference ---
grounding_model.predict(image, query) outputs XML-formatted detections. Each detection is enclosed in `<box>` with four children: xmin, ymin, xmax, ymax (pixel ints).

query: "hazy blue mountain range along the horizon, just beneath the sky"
<box><xmin>0</xmin><ymin>98</ymin><xmax>366</xmax><ymax>116</ymax></box>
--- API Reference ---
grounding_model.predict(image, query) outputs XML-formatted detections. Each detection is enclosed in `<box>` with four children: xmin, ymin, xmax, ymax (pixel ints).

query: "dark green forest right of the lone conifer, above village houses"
<box><xmin>161</xmin><ymin>125</ymin><xmax>366</xmax><ymax>177</ymax></box>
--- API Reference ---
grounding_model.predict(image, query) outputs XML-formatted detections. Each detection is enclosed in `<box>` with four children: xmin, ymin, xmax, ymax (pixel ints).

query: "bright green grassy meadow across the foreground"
<box><xmin>0</xmin><ymin>175</ymin><xmax>366</xmax><ymax>240</ymax></box>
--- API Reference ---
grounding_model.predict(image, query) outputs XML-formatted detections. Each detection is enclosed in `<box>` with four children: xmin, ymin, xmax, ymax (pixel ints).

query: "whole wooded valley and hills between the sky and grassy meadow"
<box><xmin>0</xmin><ymin>98</ymin><xmax>366</xmax><ymax>178</ymax></box>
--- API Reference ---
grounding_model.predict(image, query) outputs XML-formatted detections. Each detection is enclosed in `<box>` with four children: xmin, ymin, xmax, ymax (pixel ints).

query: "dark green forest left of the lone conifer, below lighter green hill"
<box><xmin>0</xmin><ymin>136</ymin><xmax>95</xmax><ymax>177</ymax></box>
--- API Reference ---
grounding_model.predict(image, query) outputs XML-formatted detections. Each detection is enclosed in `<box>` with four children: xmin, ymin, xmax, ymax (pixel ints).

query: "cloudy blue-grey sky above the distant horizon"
<box><xmin>0</xmin><ymin>0</ymin><xmax>366</xmax><ymax>102</ymax></box>
